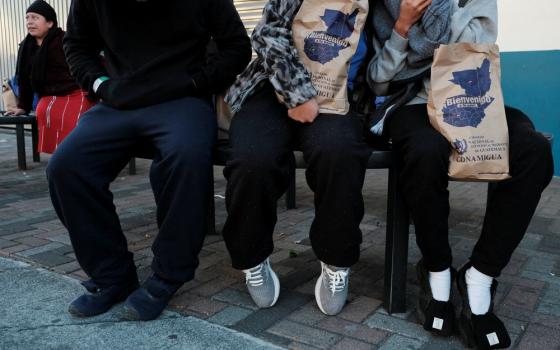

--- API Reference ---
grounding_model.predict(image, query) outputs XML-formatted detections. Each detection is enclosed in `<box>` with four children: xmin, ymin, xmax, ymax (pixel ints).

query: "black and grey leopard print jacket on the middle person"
<box><xmin>225</xmin><ymin>0</ymin><xmax>317</xmax><ymax>114</ymax></box>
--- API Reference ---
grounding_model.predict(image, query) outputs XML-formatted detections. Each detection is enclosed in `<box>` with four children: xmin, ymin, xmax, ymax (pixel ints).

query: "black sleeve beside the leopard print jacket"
<box><xmin>192</xmin><ymin>0</ymin><xmax>251</xmax><ymax>93</ymax></box>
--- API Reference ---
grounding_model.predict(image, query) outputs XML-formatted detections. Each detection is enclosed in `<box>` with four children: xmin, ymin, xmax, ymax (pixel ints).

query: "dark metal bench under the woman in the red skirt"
<box><xmin>0</xmin><ymin>112</ymin><xmax>41</xmax><ymax>170</ymax></box>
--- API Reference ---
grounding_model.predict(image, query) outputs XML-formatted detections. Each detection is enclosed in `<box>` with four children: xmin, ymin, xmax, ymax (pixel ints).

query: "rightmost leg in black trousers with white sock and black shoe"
<box><xmin>457</xmin><ymin>108</ymin><xmax>553</xmax><ymax>348</ymax></box>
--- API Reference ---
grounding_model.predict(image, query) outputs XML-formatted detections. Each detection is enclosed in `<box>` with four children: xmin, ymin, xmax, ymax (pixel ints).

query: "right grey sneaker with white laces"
<box><xmin>315</xmin><ymin>262</ymin><xmax>350</xmax><ymax>315</ymax></box>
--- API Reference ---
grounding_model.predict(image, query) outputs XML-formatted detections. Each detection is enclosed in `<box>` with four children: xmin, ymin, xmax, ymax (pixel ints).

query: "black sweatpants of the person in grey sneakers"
<box><xmin>223</xmin><ymin>84</ymin><xmax>369</xmax><ymax>269</ymax></box>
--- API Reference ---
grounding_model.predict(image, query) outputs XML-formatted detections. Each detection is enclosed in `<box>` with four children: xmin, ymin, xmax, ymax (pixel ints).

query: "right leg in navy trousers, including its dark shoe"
<box><xmin>121</xmin><ymin>97</ymin><xmax>217</xmax><ymax>320</ymax></box>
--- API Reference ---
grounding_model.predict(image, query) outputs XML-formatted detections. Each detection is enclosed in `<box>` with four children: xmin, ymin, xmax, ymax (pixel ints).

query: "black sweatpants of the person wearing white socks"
<box><xmin>388</xmin><ymin>104</ymin><xmax>553</xmax><ymax>277</ymax></box>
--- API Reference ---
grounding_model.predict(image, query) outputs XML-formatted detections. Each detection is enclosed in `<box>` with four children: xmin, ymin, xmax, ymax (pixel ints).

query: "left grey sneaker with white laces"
<box><xmin>243</xmin><ymin>258</ymin><xmax>280</xmax><ymax>308</ymax></box>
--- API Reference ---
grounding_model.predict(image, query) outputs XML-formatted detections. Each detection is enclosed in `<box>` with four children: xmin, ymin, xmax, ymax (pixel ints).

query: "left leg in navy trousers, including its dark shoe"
<box><xmin>47</xmin><ymin>105</ymin><xmax>138</xmax><ymax>316</ymax></box>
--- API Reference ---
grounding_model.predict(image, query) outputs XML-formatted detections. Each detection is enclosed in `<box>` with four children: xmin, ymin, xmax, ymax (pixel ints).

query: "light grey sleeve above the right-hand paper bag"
<box><xmin>451</xmin><ymin>0</ymin><xmax>498</xmax><ymax>43</ymax></box>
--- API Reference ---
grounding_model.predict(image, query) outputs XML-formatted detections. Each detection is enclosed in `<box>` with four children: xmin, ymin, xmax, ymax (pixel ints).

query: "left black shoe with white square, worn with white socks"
<box><xmin>416</xmin><ymin>260</ymin><xmax>456</xmax><ymax>337</ymax></box>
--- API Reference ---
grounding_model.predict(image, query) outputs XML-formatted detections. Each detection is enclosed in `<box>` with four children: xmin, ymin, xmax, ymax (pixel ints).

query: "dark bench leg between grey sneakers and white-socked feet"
<box><xmin>384</xmin><ymin>160</ymin><xmax>409</xmax><ymax>313</ymax></box>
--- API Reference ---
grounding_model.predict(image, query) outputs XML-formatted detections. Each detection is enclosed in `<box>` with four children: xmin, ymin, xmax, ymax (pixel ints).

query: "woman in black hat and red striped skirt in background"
<box><xmin>6</xmin><ymin>0</ymin><xmax>93</xmax><ymax>153</ymax></box>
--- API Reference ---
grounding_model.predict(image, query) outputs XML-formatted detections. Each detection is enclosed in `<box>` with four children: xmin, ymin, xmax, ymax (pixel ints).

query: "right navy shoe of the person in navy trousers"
<box><xmin>123</xmin><ymin>274</ymin><xmax>183</xmax><ymax>321</ymax></box>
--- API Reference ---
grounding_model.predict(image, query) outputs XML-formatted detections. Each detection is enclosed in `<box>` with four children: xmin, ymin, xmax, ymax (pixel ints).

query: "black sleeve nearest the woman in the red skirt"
<box><xmin>63</xmin><ymin>0</ymin><xmax>108</xmax><ymax>95</ymax></box>
